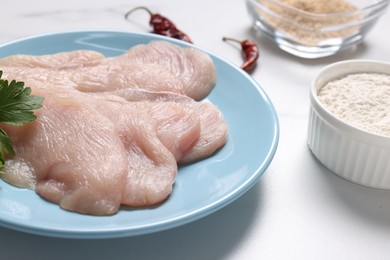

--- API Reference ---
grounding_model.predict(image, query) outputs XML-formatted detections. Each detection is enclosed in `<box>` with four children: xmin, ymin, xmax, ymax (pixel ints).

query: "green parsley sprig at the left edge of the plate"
<box><xmin>0</xmin><ymin>70</ymin><xmax>43</xmax><ymax>173</ymax></box>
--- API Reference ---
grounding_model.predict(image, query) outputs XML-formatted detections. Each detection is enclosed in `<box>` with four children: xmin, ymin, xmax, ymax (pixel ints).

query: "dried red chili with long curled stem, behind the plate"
<box><xmin>125</xmin><ymin>6</ymin><xmax>192</xmax><ymax>43</ymax></box>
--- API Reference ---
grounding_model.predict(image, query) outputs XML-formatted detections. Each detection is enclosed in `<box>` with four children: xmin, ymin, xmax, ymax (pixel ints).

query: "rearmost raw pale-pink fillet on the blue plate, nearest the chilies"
<box><xmin>0</xmin><ymin>41</ymin><xmax>216</xmax><ymax>100</ymax></box>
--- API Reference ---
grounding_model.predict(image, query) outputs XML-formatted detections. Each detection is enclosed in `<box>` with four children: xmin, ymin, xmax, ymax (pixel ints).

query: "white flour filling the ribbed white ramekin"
<box><xmin>318</xmin><ymin>73</ymin><xmax>390</xmax><ymax>136</ymax></box>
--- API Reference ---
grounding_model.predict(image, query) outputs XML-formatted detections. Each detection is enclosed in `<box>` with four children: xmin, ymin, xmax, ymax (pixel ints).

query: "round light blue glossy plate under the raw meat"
<box><xmin>0</xmin><ymin>31</ymin><xmax>279</xmax><ymax>238</ymax></box>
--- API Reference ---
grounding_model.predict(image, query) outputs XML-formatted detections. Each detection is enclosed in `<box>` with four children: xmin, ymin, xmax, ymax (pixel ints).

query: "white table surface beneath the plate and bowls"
<box><xmin>0</xmin><ymin>0</ymin><xmax>390</xmax><ymax>260</ymax></box>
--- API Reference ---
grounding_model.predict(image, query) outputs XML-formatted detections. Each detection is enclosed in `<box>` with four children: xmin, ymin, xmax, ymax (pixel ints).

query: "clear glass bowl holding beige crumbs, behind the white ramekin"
<box><xmin>246</xmin><ymin>0</ymin><xmax>389</xmax><ymax>58</ymax></box>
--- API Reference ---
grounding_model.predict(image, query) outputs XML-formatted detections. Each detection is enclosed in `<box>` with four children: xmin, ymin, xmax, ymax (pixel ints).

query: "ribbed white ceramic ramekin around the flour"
<box><xmin>308</xmin><ymin>60</ymin><xmax>390</xmax><ymax>189</ymax></box>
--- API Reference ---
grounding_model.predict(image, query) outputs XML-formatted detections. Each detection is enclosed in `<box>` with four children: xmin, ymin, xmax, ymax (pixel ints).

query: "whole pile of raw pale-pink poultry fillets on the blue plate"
<box><xmin>0</xmin><ymin>41</ymin><xmax>227</xmax><ymax>215</ymax></box>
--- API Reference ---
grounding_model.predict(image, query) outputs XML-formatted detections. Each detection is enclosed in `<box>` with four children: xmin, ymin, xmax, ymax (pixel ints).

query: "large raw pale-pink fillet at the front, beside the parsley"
<box><xmin>2</xmin><ymin>91</ymin><xmax>199</xmax><ymax>215</ymax></box>
